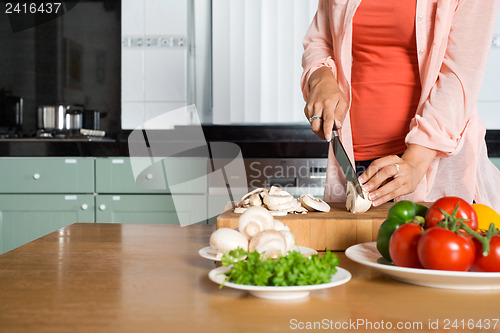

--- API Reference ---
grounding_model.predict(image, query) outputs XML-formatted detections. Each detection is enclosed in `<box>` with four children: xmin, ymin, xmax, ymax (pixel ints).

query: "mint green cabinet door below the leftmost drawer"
<box><xmin>0</xmin><ymin>194</ymin><xmax>94</xmax><ymax>253</ymax></box>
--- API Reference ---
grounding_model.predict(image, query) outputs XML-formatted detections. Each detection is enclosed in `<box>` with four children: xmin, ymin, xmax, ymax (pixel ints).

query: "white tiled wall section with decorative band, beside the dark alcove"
<box><xmin>122</xmin><ymin>0</ymin><xmax>189</xmax><ymax>129</ymax></box>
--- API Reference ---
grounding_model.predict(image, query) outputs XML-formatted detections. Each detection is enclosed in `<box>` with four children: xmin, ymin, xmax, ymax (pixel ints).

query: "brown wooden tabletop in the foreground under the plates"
<box><xmin>0</xmin><ymin>223</ymin><xmax>500</xmax><ymax>333</ymax></box>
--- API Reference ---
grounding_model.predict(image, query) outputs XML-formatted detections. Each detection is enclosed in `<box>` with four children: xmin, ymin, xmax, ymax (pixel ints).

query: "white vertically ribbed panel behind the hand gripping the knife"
<box><xmin>212</xmin><ymin>0</ymin><xmax>318</xmax><ymax>124</ymax></box>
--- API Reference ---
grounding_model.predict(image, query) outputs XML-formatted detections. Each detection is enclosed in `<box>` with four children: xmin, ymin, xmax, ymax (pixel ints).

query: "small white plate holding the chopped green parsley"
<box><xmin>208</xmin><ymin>267</ymin><xmax>351</xmax><ymax>300</ymax></box>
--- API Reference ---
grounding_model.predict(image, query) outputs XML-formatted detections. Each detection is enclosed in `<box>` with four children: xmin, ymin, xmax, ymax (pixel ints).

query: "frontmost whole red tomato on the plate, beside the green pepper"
<box><xmin>417</xmin><ymin>227</ymin><xmax>476</xmax><ymax>271</ymax></box>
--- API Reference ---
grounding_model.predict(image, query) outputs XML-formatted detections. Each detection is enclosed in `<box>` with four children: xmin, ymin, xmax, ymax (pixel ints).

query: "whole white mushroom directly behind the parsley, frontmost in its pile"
<box><xmin>248</xmin><ymin>230</ymin><xmax>287</xmax><ymax>258</ymax></box>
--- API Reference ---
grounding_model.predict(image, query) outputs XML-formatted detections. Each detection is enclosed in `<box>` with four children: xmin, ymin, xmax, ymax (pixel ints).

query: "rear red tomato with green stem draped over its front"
<box><xmin>424</xmin><ymin>197</ymin><xmax>477</xmax><ymax>230</ymax></box>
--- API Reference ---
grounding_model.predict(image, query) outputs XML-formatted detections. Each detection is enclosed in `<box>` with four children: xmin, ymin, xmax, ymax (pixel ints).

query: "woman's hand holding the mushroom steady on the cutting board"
<box><xmin>359</xmin><ymin>144</ymin><xmax>437</xmax><ymax>206</ymax></box>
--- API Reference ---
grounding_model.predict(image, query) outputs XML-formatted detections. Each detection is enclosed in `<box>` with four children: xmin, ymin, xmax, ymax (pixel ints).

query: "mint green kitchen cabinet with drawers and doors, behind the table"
<box><xmin>0</xmin><ymin>157</ymin><xmax>208</xmax><ymax>254</ymax></box>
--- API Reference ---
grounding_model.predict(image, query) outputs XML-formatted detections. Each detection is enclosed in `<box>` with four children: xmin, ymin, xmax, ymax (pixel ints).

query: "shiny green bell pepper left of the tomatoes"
<box><xmin>377</xmin><ymin>200</ymin><xmax>427</xmax><ymax>261</ymax></box>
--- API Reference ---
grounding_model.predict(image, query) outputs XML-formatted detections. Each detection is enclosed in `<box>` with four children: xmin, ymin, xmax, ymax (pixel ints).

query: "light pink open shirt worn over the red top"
<box><xmin>301</xmin><ymin>0</ymin><xmax>500</xmax><ymax>208</ymax></box>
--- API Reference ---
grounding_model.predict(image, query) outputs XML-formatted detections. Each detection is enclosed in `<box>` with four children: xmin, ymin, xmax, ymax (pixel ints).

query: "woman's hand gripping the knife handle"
<box><xmin>304</xmin><ymin>67</ymin><xmax>347</xmax><ymax>141</ymax></box>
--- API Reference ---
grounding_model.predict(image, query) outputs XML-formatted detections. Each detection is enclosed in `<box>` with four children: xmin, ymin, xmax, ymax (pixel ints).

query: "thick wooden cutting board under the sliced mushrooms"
<box><xmin>217</xmin><ymin>202</ymin><xmax>394</xmax><ymax>251</ymax></box>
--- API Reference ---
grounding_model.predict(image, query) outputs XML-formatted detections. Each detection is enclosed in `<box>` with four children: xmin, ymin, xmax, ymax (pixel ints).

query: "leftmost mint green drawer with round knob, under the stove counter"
<box><xmin>0</xmin><ymin>157</ymin><xmax>94</xmax><ymax>193</ymax></box>
